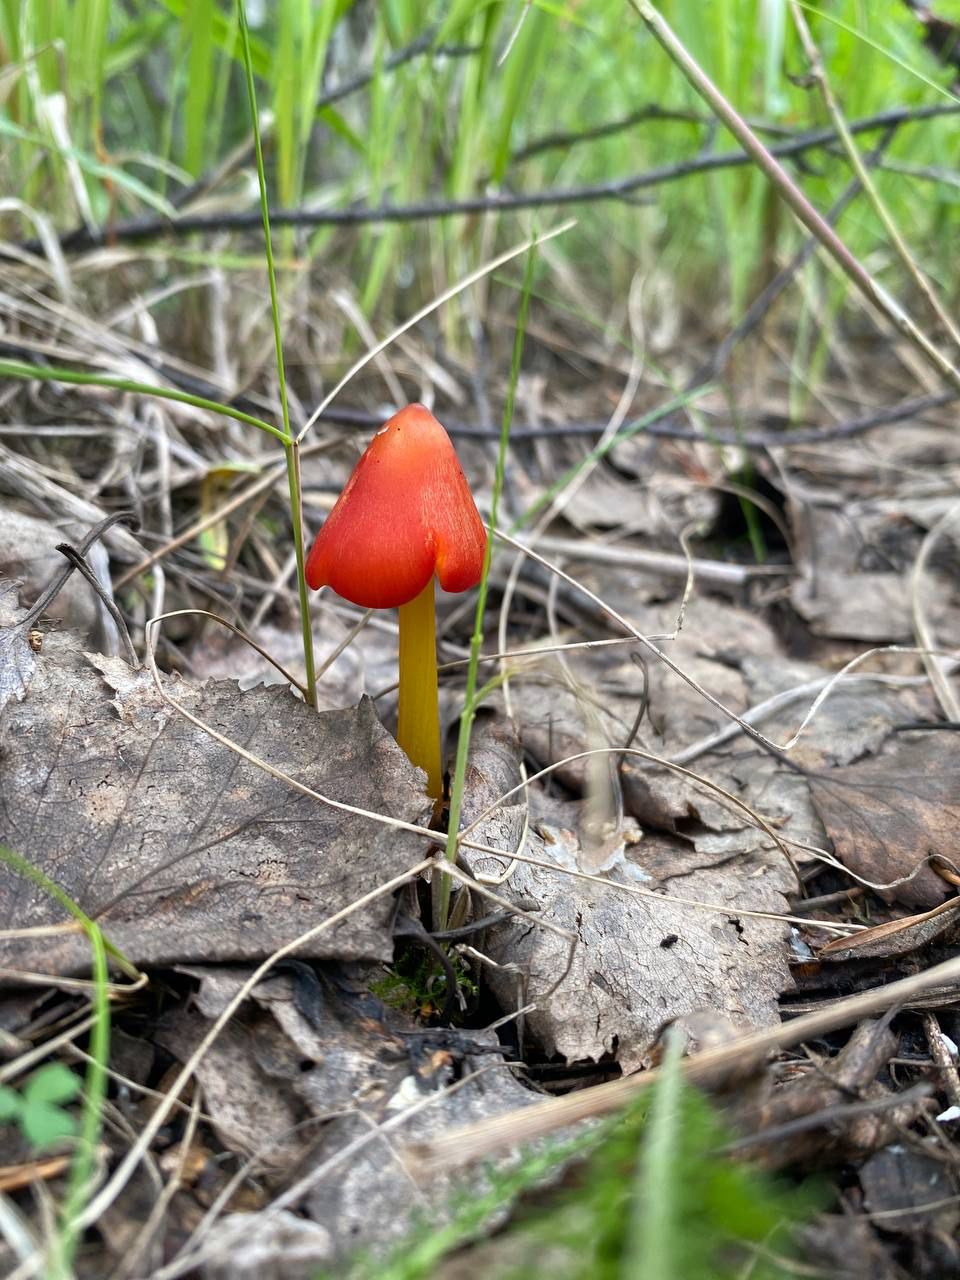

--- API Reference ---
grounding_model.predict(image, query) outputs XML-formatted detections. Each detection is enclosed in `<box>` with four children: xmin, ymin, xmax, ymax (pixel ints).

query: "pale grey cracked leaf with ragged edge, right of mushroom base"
<box><xmin>463</xmin><ymin>722</ymin><xmax>795</xmax><ymax>1071</ymax></box>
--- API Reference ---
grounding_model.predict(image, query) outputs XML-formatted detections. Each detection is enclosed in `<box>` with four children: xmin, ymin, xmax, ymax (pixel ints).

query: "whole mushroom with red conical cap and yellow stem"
<box><xmin>306</xmin><ymin>404</ymin><xmax>486</xmax><ymax>800</ymax></box>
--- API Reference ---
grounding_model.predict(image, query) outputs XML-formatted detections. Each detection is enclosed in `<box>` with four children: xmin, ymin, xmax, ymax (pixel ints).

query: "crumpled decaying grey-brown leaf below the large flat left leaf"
<box><xmin>159</xmin><ymin>964</ymin><xmax>536</xmax><ymax>1274</ymax></box>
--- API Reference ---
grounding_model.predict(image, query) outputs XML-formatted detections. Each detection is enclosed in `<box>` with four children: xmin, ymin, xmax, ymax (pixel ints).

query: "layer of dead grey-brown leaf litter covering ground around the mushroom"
<box><xmin>0</xmin><ymin>254</ymin><xmax>957</xmax><ymax>1275</ymax></box>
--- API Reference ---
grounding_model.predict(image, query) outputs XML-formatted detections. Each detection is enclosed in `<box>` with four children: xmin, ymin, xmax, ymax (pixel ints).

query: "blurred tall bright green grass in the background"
<box><xmin>0</xmin><ymin>0</ymin><xmax>960</xmax><ymax>345</ymax></box>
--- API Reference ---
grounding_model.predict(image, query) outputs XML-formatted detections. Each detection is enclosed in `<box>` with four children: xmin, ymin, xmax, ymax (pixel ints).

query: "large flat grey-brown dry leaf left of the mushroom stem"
<box><xmin>0</xmin><ymin>624</ymin><xmax>430</xmax><ymax>973</ymax></box>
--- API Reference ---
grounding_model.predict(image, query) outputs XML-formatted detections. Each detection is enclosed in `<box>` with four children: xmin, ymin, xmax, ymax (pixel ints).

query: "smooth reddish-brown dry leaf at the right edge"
<box><xmin>809</xmin><ymin>732</ymin><xmax>960</xmax><ymax>909</ymax></box>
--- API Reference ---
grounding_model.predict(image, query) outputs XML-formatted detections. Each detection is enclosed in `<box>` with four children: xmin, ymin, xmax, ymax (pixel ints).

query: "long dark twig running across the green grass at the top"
<box><xmin>19</xmin><ymin>104</ymin><xmax>960</xmax><ymax>253</ymax></box>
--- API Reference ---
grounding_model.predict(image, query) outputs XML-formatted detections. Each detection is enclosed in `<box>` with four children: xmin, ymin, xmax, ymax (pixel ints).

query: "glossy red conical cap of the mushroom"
<box><xmin>306</xmin><ymin>404</ymin><xmax>486</xmax><ymax>609</ymax></box>
